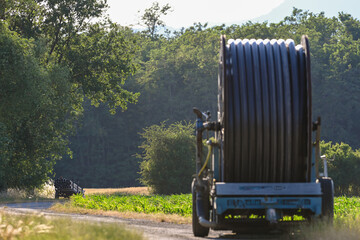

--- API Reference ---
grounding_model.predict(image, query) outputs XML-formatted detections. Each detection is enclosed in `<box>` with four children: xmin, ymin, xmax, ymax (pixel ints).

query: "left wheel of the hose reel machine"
<box><xmin>191</xmin><ymin>179</ymin><xmax>210</xmax><ymax>237</ymax></box>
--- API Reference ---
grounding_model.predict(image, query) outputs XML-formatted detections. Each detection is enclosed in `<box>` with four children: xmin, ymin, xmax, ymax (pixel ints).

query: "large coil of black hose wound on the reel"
<box><xmin>219</xmin><ymin>37</ymin><xmax>311</xmax><ymax>182</ymax></box>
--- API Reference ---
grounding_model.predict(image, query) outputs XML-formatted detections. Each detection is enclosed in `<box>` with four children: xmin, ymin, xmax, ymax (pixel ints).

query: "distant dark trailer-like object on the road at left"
<box><xmin>55</xmin><ymin>177</ymin><xmax>85</xmax><ymax>199</ymax></box>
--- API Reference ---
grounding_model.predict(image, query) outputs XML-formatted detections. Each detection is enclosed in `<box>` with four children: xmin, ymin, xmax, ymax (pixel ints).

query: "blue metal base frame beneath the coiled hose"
<box><xmin>214</xmin><ymin>182</ymin><xmax>322</xmax><ymax>219</ymax></box>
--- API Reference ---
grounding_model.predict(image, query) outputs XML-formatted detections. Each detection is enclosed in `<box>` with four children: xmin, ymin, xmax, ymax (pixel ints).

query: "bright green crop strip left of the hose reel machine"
<box><xmin>71</xmin><ymin>194</ymin><xmax>191</xmax><ymax>217</ymax></box>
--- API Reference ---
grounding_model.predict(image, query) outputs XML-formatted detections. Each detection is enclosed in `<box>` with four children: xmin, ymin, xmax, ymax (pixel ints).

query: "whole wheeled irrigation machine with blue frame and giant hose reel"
<box><xmin>192</xmin><ymin>36</ymin><xmax>334</xmax><ymax>237</ymax></box>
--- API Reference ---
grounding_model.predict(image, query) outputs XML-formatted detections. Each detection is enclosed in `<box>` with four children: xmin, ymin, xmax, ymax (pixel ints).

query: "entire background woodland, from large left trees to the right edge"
<box><xmin>0</xmin><ymin>0</ymin><xmax>360</xmax><ymax>189</ymax></box>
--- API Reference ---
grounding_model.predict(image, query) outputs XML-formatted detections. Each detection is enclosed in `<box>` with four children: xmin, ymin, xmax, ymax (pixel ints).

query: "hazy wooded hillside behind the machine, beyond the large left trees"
<box><xmin>56</xmin><ymin>9</ymin><xmax>360</xmax><ymax>187</ymax></box>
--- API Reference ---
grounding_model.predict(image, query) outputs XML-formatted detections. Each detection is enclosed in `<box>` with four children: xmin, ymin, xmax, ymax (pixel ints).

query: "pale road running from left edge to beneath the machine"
<box><xmin>1</xmin><ymin>202</ymin><xmax>288</xmax><ymax>240</ymax></box>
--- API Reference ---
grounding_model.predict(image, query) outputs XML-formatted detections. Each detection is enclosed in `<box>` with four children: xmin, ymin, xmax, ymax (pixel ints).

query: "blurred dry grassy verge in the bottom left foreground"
<box><xmin>0</xmin><ymin>212</ymin><xmax>143</xmax><ymax>240</ymax></box>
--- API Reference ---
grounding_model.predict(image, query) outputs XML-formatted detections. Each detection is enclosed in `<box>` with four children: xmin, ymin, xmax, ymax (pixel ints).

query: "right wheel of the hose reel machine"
<box><xmin>319</xmin><ymin>177</ymin><xmax>334</xmax><ymax>221</ymax></box>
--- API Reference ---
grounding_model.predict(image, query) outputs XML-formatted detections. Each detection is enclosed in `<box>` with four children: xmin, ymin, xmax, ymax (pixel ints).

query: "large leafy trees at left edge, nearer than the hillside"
<box><xmin>0</xmin><ymin>0</ymin><xmax>139</xmax><ymax>189</ymax></box>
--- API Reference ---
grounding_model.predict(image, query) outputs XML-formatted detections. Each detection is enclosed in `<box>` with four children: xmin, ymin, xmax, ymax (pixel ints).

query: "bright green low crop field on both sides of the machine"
<box><xmin>71</xmin><ymin>194</ymin><xmax>360</xmax><ymax>222</ymax></box>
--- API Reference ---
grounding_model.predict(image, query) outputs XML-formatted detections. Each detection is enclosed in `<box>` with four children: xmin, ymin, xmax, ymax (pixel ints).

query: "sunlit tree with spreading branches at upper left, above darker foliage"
<box><xmin>4</xmin><ymin>0</ymin><xmax>138</xmax><ymax>112</ymax></box>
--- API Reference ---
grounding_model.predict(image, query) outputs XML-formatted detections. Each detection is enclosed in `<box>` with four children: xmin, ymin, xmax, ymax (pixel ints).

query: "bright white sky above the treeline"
<box><xmin>108</xmin><ymin>0</ymin><xmax>285</xmax><ymax>29</ymax></box>
